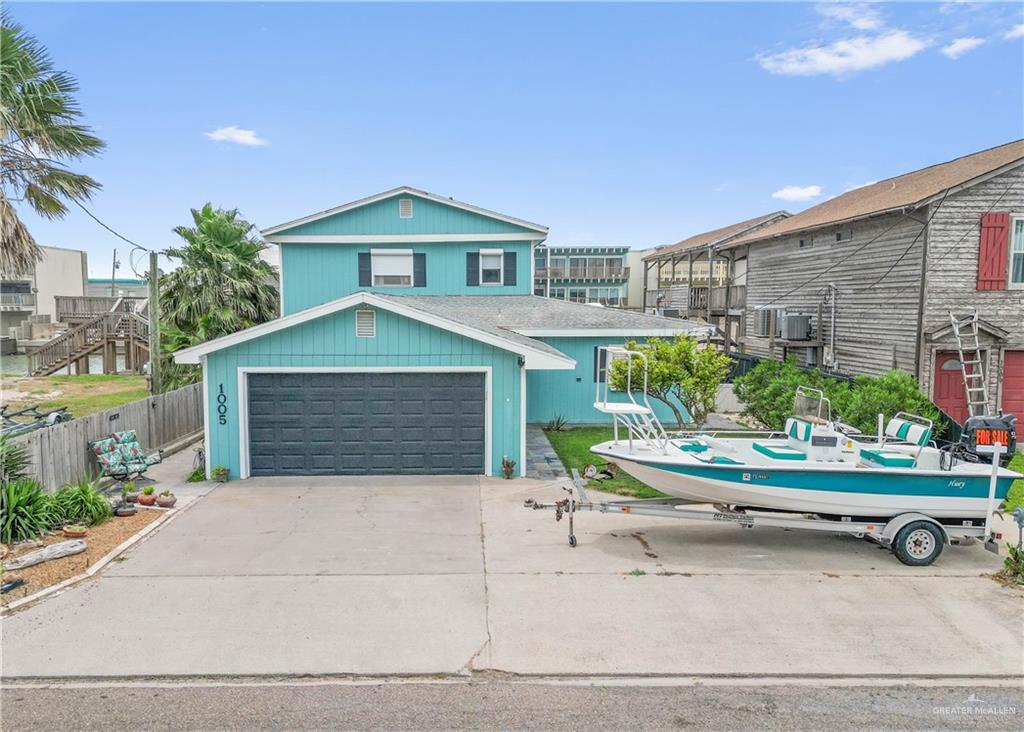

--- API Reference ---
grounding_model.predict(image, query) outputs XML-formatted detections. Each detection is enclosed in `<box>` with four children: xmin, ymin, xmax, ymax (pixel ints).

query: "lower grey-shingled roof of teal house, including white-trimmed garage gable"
<box><xmin>174</xmin><ymin>292</ymin><xmax>714</xmax><ymax>369</ymax></box>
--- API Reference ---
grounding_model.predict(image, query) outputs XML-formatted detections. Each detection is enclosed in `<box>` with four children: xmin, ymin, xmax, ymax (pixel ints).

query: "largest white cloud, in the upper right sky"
<box><xmin>758</xmin><ymin>31</ymin><xmax>928</xmax><ymax>77</ymax></box>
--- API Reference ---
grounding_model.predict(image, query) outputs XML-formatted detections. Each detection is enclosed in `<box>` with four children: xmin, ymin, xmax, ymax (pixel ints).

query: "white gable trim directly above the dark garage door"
<box><xmin>174</xmin><ymin>292</ymin><xmax>575</xmax><ymax>369</ymax></box>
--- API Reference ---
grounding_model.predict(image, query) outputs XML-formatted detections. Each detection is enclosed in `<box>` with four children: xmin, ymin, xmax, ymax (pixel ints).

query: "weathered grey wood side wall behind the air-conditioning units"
<box><xmin>743</xmin><ymin>212</ymin><xmax>927</xmax><ymax>375</ymax></box>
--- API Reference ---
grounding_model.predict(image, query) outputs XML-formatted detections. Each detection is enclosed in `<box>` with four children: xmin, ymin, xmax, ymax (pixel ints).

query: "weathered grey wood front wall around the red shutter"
<box><xmin>921</xmin><ymin>167</ymin><xmax>1024</xmax><ymax>411</ymax></box>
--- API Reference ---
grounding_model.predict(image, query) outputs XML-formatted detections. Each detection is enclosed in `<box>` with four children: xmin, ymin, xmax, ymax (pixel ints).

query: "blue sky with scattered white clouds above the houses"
<box><xmin>8</xmin><ymin>2</ymin><xmax>1024</xmax><ymax>276</ymax></box>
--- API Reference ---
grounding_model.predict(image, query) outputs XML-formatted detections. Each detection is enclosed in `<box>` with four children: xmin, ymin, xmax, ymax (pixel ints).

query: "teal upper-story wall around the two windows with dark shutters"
<box><xmin>281</xmin><ymin>237</ymin><xmax>532</xmax><ymax>315</ymax></box>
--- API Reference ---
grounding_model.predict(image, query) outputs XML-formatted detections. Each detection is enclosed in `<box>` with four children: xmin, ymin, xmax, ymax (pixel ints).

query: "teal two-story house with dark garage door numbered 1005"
<box><xmin>175</xmin><ymin>187</ymin><xmax>707</xmax><ymax>478</ymax></box>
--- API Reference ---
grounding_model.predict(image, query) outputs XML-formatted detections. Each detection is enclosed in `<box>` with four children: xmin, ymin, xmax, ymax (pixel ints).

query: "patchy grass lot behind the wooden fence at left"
<box><xmin>4</xmin><ymin>374</ymin><xmax>148</xmax><ymax>417</ymax></box>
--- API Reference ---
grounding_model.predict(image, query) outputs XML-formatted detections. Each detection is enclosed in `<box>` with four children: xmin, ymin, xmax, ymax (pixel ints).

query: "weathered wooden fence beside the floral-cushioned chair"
<box><xmin>11</xmin><ymin>384</ymin><xmax>203</xmax><ymax>490</ymax></box>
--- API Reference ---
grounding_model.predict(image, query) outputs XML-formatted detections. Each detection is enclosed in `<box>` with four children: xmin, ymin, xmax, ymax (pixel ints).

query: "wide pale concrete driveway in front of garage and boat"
<box><xmin>2</xmin><ymin>478</ymin><xmax>1024</xmax><ymax>677</ymax></box>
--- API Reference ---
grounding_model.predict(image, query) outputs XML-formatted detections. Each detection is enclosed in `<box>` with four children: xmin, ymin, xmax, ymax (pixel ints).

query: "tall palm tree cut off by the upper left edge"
<box><xmin>0</xmin><ymin>11</ymin><xmax>103</xmax><ymax>273</ymax></box>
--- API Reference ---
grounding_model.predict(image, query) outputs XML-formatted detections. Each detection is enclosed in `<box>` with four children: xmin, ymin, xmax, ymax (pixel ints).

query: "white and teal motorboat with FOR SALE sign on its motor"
<box><xmin>591</xmin><ymin>347</ymin><xmax>1022</xmax><ymax>525</ymax></box>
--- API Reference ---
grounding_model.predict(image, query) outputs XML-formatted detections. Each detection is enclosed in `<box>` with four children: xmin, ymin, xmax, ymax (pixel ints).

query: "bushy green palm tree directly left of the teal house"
<box><xmin>160</xmin><ymin>204</ymin><xmax>279</xmax><ymax>390</ymax></box>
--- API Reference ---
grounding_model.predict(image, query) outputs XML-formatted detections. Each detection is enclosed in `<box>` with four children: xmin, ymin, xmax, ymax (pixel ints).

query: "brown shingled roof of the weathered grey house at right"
<box><xmin>728</xmin><ymin>139</ymin><xmax>1024</xmax><ymax>247</ymax></box>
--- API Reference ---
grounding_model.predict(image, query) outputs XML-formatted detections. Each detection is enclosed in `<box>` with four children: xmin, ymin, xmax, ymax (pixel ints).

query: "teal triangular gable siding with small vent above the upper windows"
<box><xmin>280</xmin><ymin>195</ymin><xmax>543</xmax><ymax>239</ymax></box>
